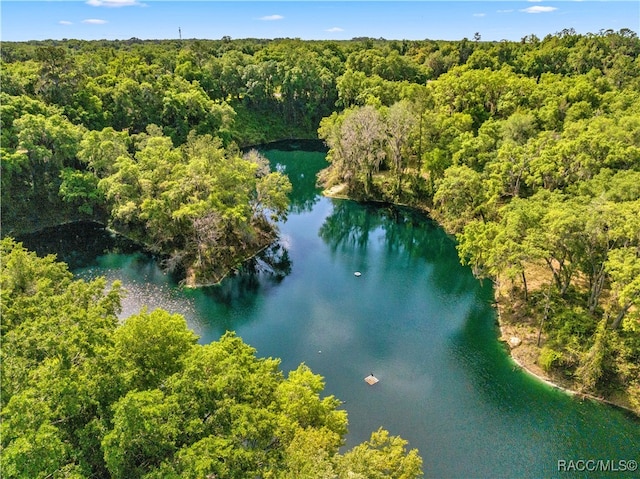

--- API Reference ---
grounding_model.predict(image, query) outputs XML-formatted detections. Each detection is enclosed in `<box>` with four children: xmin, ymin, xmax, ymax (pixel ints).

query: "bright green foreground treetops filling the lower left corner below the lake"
<box><xmin>0</xmin><ymin>239</ymin><xmax>422</xmax><ymax>479</ymax></box>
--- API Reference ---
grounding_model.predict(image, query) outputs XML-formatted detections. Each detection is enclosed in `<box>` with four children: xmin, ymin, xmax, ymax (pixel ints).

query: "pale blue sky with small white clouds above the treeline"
<box><xmin>0</xmin><ymin>0</ymin><xmax>640</xmax><ymax>41</ymax></box>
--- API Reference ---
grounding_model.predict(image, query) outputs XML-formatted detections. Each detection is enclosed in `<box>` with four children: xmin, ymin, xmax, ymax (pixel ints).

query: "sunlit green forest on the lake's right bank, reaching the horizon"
<box><xmin>318</xmin><ymin>30</ymin><xmax>640</xmax><ymax>409</ymax></box>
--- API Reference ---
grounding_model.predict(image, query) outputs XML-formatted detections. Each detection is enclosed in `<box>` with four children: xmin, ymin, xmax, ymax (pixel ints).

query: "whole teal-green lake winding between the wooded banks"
<box><xmin>20</xmin><ymin>142</ymin><xmax>640</xmax><ymax>478</ymax></box>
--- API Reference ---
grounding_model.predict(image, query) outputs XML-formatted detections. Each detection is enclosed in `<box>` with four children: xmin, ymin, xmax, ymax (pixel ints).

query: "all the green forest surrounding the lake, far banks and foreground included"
<box><xmin>0</xmin><ymin>29</ymin><xmax>640</xmax><ymax>477</ymax></box>
